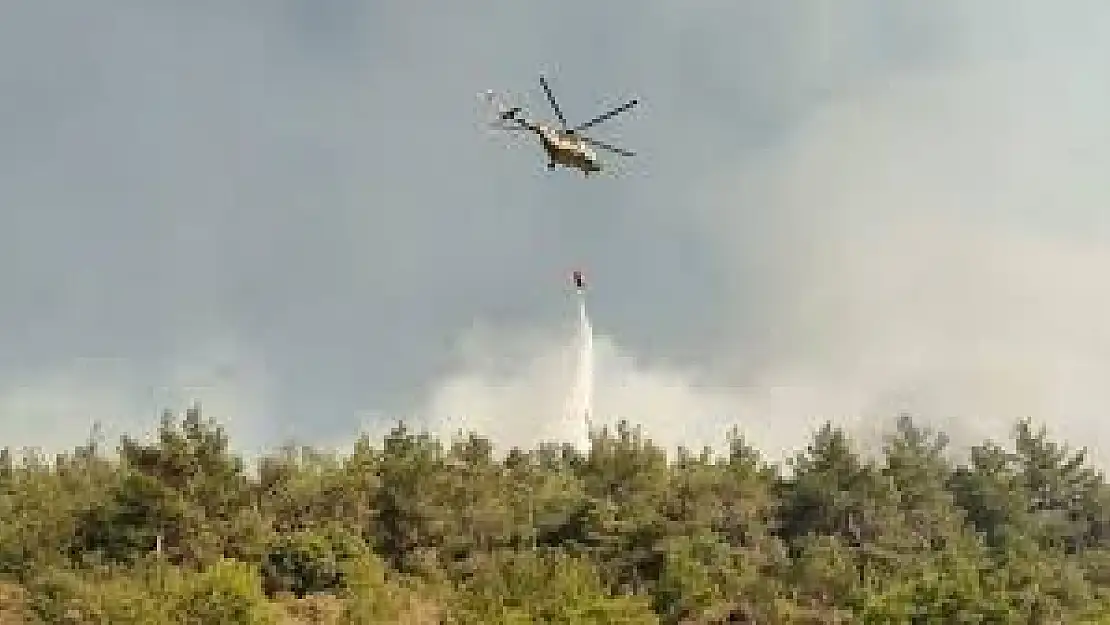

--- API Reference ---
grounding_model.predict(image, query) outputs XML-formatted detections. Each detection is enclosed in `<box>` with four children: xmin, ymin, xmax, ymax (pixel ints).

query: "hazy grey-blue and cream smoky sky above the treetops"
<box><xmin>0</xmin><ymin>0</ymin><xmax>1110</xmax><ymax>464</ymax></box>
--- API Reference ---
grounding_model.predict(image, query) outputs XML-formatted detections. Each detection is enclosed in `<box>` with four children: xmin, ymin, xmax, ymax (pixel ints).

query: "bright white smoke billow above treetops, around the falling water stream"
<box><xmin>419</xmin><ymin>286</ymin><xmax>759</xmax><ymax>456</ymax></box>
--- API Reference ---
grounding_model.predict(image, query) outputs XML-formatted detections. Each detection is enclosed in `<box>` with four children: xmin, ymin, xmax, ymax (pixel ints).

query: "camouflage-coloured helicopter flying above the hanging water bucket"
<box><xmin>485</xmin><ymin>74</ymin><xmax>639</xmax><ymax>177</ymax></box>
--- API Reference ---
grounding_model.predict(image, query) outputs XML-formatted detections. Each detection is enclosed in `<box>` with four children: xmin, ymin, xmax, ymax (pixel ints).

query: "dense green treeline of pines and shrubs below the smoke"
<box><xmin>0</xmin><ymin>409</ymin><xmax>1110</xmax><ymax>625</ymax></box>
